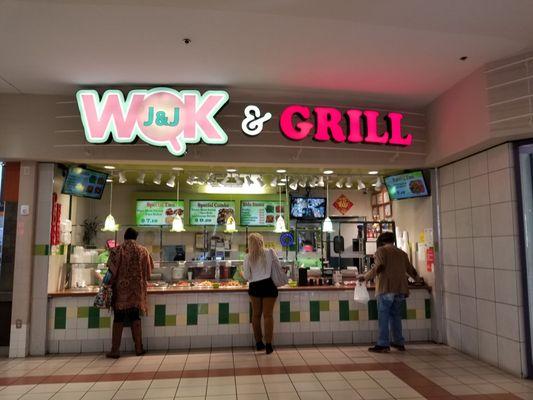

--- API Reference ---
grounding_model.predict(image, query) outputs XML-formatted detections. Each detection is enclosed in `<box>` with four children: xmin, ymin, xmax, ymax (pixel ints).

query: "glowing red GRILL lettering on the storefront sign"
<box><xmin>279</xmin><ymin>105</ymin><xmax>413</xmax><ymax>146</ymax></box>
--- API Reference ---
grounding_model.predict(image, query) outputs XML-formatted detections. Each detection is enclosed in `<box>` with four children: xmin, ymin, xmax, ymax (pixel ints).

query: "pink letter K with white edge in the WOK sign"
<box><xmin>183</xmin><ymin>94</ymin><xmax>225</xmax><ymax>141</ymax></box>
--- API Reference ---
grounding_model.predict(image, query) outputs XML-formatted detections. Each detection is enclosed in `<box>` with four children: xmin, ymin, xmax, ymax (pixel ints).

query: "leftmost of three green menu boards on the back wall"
<box><xmin>135</xmin><ymin>200</ymin><xmax>185</xmax><ymax>226</ymax></box>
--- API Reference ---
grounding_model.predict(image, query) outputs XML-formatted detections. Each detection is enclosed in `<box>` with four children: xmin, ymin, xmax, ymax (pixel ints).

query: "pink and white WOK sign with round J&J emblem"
<box><xmin>76</xmin><ymin>88</ymin><xmax>229</xmax><ymax>156</ymax></box>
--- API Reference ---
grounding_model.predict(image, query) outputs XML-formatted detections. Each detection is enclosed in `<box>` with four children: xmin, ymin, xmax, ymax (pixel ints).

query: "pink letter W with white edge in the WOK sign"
<box><xmin>81</xmin><ymin>93</ymin><xmax>144</xmax><ymax>140</ymax></box>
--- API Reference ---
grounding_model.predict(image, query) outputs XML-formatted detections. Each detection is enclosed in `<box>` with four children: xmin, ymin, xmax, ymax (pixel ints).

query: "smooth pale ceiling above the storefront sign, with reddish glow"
<box><xmin>0</xmin><ymin>0</ymin><xmax>533</xmax><ymax>110</ymax></box>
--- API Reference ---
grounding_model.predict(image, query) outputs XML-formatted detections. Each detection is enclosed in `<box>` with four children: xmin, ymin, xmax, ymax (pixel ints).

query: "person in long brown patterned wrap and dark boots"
<box><xmin>106</xmin><ymin>228</ymin><xmax>154</xmax><ymax>358</ymax></box>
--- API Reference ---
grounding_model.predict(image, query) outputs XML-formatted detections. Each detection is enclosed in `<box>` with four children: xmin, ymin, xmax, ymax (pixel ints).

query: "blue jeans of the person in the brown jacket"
<box><xmin>376</xmin><ymin>293</ymin><xmax>405</xmax><ymax>347</ymax></box>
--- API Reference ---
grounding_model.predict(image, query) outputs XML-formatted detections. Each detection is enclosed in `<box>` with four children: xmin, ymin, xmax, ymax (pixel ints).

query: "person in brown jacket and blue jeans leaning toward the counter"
<box><xmin>359</xmin><ymin>232</ymin><xmax>418</xmax><ymax>353</ymax></box>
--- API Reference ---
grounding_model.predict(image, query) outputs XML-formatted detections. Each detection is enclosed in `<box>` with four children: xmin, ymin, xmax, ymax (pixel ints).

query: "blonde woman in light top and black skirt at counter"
<box><xmin>243</xmin><ymin>233</ymin><xmax>280</xmax><ymax>354</ymax></box>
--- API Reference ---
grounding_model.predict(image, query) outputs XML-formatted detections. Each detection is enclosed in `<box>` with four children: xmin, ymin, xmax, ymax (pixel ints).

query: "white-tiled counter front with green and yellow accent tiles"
<box><xmin>47</xmin><ymin>286</ymin><xmax>432</xmax><ymax>353</ymax></box>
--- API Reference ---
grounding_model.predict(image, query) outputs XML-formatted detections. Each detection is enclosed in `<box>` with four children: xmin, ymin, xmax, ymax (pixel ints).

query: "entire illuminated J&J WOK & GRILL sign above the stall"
<box><xmin>76</xmin><ymin>87</ymin><xmax>413</xmax><ymax>156</ymax></box>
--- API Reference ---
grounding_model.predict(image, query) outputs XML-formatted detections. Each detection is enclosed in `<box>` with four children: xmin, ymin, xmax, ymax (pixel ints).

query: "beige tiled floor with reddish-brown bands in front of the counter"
<box><xmin>0</xmin><ymin>344</ymin><xmax>533</xmax><ymax>400</ymax></box>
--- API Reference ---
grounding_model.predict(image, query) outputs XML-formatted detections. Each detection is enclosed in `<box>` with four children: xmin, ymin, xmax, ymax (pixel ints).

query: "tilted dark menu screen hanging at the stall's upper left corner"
<box><xmin>61</xmin><ymin>167</ymin><xmax>108</xmax><ymax>199</ymax></box>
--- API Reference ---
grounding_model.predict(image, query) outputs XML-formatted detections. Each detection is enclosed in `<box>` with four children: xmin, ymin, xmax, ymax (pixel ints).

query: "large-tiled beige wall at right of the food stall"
<box><xmin>439</xmin><ymin>144</ymin><xmax>526</xmax><ymax>375</ymax></box>
